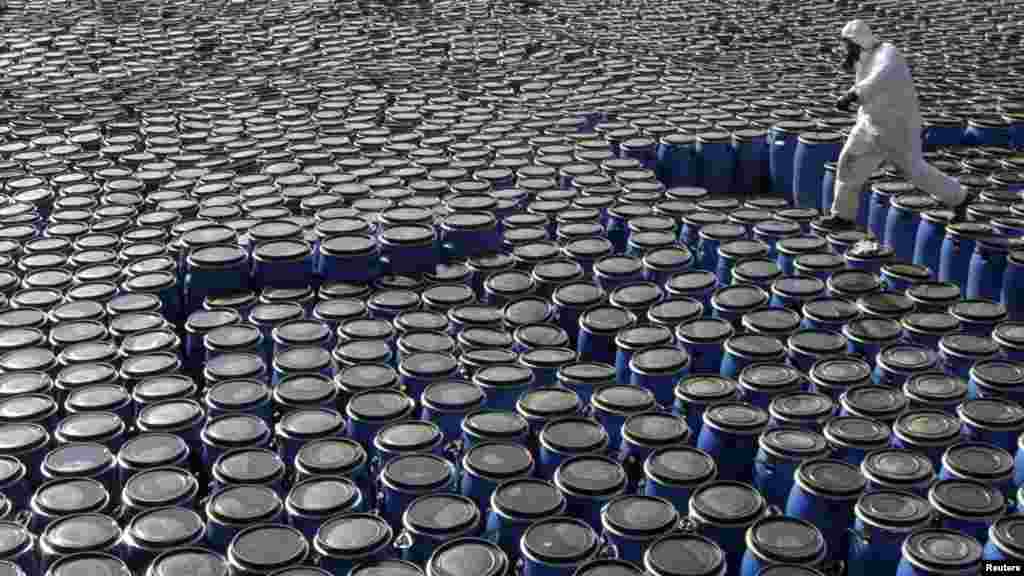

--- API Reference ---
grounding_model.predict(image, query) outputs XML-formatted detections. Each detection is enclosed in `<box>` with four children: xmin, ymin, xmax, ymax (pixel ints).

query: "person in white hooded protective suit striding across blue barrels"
<box><xmin>821</xmin><ymin>19</ymin><xmax>968</xmax><ymax>229</ymax></box>
